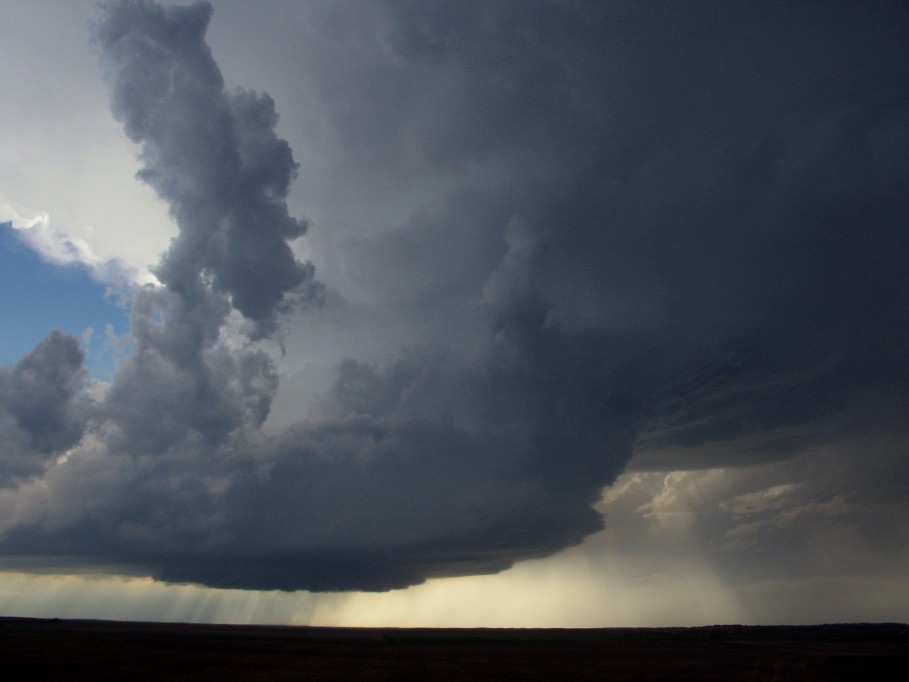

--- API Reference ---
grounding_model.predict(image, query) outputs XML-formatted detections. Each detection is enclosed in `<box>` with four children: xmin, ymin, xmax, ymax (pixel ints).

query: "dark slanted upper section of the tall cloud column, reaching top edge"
<box><xmin>96</xmin><ymin>0</ymin><xmax>318</xmax><ymax>333</ymax></box>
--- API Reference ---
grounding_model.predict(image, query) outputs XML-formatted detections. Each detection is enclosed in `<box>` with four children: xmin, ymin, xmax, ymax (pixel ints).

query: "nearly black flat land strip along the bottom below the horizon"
<box><xmin>0</xmin><ymin>618</ymin><xmax>909</xmax><ymax>682</ymax></box>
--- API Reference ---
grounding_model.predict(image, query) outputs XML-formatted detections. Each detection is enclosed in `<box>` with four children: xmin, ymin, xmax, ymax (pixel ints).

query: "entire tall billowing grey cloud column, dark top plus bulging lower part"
<box><xmin>97</xmin><ymin>2</ymin><xmax>319</xmax><ymax>452</ymax></box>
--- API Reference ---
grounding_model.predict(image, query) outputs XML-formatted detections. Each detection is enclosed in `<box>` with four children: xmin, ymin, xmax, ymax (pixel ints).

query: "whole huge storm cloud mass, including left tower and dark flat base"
<box><xmin>0</xmin><ymin>0</ymin><xmax>909</xmax><ymax>590</ymax></box>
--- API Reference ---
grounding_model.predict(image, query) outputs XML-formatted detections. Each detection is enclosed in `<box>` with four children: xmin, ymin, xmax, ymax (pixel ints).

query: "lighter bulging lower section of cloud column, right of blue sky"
<box><xmin>103</xmin><ymin>290</ymin><xmax>277</xmax><ymax>452</ymax></box>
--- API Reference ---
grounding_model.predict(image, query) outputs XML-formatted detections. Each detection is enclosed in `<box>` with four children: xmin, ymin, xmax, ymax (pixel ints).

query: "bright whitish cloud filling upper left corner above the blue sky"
<box><xmin>0</xmin><ymin>0</ymin><xmax>176</xmax><ymax>283</ymax></box>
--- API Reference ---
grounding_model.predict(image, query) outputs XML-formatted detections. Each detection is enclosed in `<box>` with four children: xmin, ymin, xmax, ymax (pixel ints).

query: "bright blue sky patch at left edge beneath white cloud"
<box><xmin>0</xmin><ymin>223</ymin><xmax>129</xmax><ymax>380</ymax></box>
